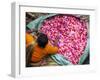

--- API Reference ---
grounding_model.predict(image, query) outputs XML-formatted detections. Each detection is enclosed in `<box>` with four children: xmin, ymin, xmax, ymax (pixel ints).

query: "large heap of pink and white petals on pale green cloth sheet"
<box><xmin>40</xmin><ymin>14</ymin><xmax>87</xmax><ymax>64</ymax></box>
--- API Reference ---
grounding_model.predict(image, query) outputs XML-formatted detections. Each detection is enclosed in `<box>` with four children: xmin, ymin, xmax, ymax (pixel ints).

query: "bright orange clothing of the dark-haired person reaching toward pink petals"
<box><xmin>26</xmin><ymin>34</ymin><xmax>58</xmax><ymax>62</ymax></box>
